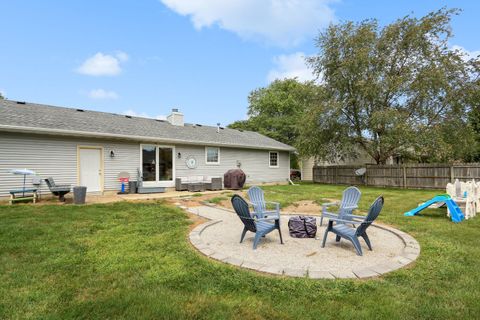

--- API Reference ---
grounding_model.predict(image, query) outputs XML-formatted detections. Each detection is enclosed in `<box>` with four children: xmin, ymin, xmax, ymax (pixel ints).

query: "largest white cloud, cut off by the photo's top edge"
<box><xmin>160</xmin><ymin>0</ymin><xmax>336</xmax><ymax>46</ymax></box>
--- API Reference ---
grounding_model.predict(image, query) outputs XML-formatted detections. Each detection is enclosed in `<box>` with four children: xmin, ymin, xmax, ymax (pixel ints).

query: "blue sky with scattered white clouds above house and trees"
<box><xmin>0</xmin><ymin>0</ymin><xmax>480</xmax><ymax>125</ymax></box>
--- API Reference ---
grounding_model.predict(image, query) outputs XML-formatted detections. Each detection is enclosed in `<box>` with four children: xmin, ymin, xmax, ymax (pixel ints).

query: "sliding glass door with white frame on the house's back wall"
<box><xmin>140</xmin><ymin>144</ymin><xmax>175</xmax><ymax>187</ymax></box>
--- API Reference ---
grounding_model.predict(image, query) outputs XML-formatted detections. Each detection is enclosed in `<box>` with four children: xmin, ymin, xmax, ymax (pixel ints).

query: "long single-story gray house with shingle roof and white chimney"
<box><xmin>0</xmin><ymin>100</ymin><xmax>295</xmax><ymax>197</ymax></box>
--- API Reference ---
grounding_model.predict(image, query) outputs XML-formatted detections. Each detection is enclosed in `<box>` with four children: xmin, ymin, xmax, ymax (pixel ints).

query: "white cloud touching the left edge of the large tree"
<box><xmin>267</xmin><ymin>52</ymin><xmax>315</xmax><ymax>82</ymax></box>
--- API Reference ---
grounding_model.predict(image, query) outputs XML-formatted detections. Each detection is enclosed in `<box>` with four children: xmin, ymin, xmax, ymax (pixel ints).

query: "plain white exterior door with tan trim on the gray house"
<box><xmin>79</xmin><ymin>147</ymin><xmax>103</xmax><ymax>192</ymax></box>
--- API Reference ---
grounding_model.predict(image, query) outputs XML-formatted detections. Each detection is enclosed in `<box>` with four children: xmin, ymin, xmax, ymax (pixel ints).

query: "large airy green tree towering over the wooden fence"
<box><xmin>297</xmin><ymin>9</ymin><xmax>479</xmax><ymax>164</ymax></box>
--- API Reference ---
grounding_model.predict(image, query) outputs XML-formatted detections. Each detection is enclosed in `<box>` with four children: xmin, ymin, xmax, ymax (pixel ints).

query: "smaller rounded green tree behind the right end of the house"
<box><xmin>228</xmin><ymin>79</ymin><xmax>320</xmax><ymax>167</ymax></box>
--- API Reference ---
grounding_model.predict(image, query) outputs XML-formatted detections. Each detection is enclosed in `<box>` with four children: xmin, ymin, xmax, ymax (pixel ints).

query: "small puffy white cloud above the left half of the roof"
<box><xmin>76</xmin><ymin>51</ymin><xmax>128</xmax><ymax>76</ymax></box>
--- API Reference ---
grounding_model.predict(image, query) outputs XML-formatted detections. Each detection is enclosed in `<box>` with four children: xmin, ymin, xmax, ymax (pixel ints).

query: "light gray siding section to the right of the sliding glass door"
<box><xmin>175</xmin><ymin>145</ymin><xmax>290</xmax><ymax>184</ymax></box>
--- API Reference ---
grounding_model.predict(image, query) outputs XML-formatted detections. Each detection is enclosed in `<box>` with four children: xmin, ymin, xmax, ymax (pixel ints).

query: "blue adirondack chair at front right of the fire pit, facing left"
<box><xmin>322</xmin><ymin>196</ymin><xmax>384</xmax><ymax>256</ymax></box>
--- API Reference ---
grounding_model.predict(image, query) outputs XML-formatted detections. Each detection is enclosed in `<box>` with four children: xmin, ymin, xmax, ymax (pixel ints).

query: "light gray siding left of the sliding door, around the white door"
<box><xmin>0</xmin><ymin>132</ymin><xmax>140</xmax><ymax>197</ymax></box>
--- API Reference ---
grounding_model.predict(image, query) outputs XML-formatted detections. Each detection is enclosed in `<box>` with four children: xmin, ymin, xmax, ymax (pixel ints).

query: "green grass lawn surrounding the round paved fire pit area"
<box><xmin>0</xmin><ymin>185</ymin><xmax>480</xmax><ymax>319</ymax></box>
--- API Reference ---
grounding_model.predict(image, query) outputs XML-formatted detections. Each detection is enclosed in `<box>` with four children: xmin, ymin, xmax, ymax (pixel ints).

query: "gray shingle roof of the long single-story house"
<box><xmin>0</xmin><ymin>100</ymin><xmax>295</xmax><ymax>151</ymax></box>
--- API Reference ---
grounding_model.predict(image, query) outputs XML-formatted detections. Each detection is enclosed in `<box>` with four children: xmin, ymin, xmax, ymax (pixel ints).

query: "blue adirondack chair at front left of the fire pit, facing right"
<box><xmin>231</xmin><ymin>195</ymin><xmax>283</xmax><ymax>249</ymax></box>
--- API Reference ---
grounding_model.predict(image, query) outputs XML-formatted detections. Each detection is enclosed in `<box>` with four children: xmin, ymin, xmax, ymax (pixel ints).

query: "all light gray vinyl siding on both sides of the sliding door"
<box><xmin>0</xmin><ymin>132</ymin><xmax>290</xmax><ymax>197</ymax></box>
